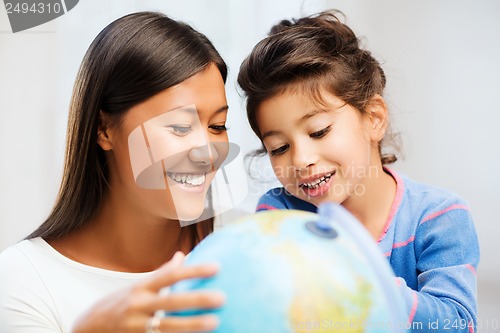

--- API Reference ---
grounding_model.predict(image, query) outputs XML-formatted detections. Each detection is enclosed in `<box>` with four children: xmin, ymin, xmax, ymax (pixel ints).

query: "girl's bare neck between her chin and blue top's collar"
<box><xmin>342</xmin><ymin>165</ymin><xmax>396</xmax><ymax>241</ymax></box>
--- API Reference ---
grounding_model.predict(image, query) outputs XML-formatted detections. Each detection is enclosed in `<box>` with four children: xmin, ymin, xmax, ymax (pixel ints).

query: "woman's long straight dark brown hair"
<box><xmin>27</xmin><ymin>12</ymin><xmax>227</xmax><ymax>243</ymax></box>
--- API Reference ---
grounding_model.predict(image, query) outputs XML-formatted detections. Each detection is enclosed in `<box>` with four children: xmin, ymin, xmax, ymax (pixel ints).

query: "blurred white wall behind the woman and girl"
<box><xmin>0</xmin><ymin>0</ymin><xmax>500</xmax><ymax>326</ymax></box>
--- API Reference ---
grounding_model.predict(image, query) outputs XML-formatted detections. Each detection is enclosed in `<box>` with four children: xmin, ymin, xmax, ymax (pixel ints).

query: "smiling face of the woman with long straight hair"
<box><xmin>101</xmin><ymin>65</ymin><xmax>228</xmax><ymax>221</ymax></box>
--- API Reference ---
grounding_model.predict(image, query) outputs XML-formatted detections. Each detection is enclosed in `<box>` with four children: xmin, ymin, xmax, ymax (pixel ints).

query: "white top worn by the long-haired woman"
<box><xmin>0</xmin><ymin>238</ymin><xmax>152</xmax><ymax>333</ymax></box>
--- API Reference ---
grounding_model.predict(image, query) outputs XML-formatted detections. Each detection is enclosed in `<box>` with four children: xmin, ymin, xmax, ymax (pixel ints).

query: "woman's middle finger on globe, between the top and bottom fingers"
<box><xmin>150</xmin><ymin>291</ymin><xmax>226</xmax><ymax>312</ymax></box>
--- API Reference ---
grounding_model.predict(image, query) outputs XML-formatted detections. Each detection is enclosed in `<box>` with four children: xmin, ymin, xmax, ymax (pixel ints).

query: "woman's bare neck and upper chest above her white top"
<box><xmin>49</xmin><ymin>192</ymin><xmax>194</xmax><ymax>272</ymax></box>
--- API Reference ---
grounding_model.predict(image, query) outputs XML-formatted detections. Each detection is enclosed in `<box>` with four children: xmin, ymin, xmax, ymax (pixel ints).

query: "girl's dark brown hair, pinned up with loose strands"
<box><xmin>238</xmin><ymin>11</ymin><xmax>396</xmax><ymax>164</ymax></box>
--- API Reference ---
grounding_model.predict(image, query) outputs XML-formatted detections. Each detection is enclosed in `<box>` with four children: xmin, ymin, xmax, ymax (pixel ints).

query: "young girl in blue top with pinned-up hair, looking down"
<box><xmin>238</xmin><ymin>12</ymin><xmax>479</xmax><ymax>332</ymax></box>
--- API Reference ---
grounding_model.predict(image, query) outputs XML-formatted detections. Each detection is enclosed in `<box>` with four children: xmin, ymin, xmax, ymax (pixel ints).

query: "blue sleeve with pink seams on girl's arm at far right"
<box><xmin>399</xmin><ymin>204</ymin><xmax>479</xmax><ymax>332</ymax></box>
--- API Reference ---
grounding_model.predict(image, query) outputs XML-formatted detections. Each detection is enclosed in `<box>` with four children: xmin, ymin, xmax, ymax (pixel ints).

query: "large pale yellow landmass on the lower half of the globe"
<box><xmin>273</xmin><ymin>240</ymin><xmax>372</xmax><ymax>333</ymax></box>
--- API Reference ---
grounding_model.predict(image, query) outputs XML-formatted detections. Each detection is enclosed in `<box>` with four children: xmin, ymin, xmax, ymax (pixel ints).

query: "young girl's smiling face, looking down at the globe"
<box><xmin>256</xmin><ymin>89</ymin><xmax>383</xmax><ymax>206</ymax></box>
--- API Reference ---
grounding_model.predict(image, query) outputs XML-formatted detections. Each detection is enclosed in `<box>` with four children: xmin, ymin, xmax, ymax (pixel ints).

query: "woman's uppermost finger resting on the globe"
<box><xmin>145</xmin><ymin>264</ymin><xmax>219</xmax><ymax>292</ymax></box>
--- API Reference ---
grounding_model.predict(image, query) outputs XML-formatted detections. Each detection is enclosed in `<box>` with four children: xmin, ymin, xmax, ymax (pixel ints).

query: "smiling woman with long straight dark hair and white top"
<box><xmin>0</xmin><ymin>12</ymin><xmax>228</xmax><ymax>333</ymax></box>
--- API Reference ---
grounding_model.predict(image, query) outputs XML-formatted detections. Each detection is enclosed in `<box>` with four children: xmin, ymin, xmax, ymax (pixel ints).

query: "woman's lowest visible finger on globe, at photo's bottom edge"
<box><xmin>160</xmin><ymin>315</ymin><xmax>219</xmax><ymax>333</ymax></box>
